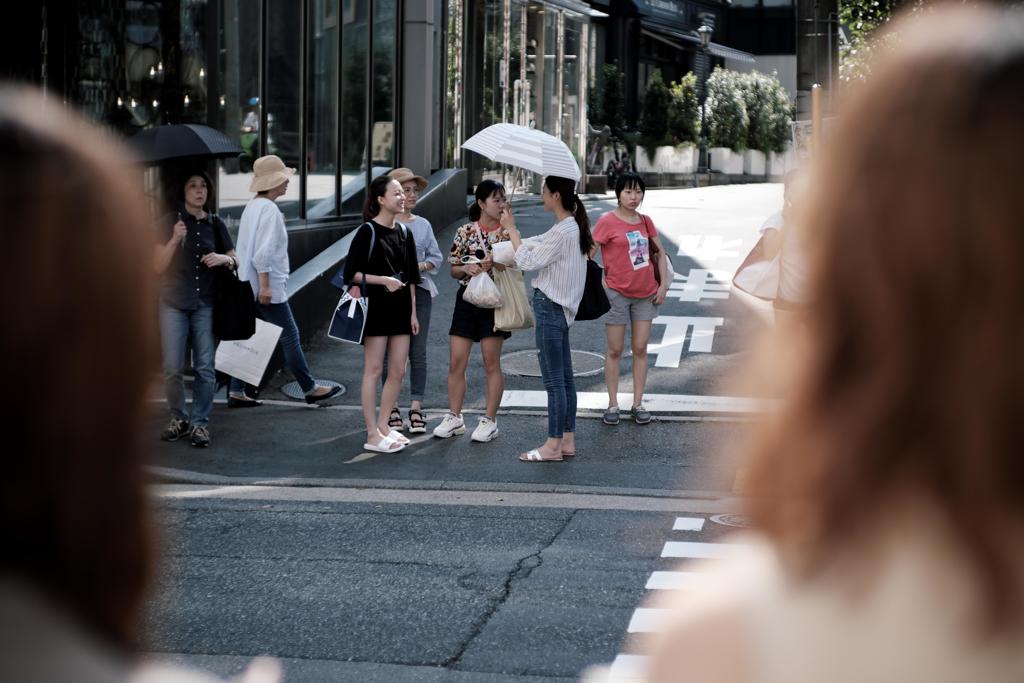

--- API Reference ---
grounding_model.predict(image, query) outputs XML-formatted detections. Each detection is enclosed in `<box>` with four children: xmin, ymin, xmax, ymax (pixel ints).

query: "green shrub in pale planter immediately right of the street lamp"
<box><xmin>705</xmin><ymin>67</ymin><xmax>749</xmax><ymax>174</ymax></box>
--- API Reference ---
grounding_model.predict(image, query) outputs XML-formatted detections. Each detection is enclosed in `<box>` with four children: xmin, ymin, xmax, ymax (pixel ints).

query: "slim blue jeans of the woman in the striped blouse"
<box><xmin>534</xmin><ymin>290</ymin><xmax>577</xmax><ymax>438</ymax></box>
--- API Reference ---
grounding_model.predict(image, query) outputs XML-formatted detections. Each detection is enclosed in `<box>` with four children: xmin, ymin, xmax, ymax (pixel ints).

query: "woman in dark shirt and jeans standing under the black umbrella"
<box><xmin>156</xmin><ymin>172</ymin><xmax>238</xmax><ymax>447</ymax></box>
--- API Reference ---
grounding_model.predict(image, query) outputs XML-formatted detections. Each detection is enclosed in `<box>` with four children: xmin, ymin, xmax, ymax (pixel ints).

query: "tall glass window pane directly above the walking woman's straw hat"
<box><xmin>264</xmin><ymin>0</ymin><xmax>302</xmax><ymax>218</ymax></box>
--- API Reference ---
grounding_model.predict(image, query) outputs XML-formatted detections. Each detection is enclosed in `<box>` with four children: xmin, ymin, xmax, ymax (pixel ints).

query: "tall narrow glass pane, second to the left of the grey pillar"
<box><xmin>341</xmin><ymin>0</ymin><xmax>369</xmax><ymax>213</ymax></box>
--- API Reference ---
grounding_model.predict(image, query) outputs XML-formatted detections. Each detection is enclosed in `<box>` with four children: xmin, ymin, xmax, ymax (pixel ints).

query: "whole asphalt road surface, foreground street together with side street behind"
<box><xmin>145</xmin><ymin>185</ymin><xmax>781</xmax><ymax>681</ymax></box>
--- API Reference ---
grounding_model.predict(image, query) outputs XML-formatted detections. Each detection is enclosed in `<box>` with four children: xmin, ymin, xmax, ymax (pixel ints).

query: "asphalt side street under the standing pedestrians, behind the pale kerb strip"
<box><xmin>150</xmin><ymin>185</ymin><xmax>781</xmax><ymax>496</ymax></box>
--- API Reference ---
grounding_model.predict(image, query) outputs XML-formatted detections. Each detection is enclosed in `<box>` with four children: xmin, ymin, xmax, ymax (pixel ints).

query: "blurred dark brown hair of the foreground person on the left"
<box><xmin>0</xmin><ymin>87</ymin><xmax>156</xmax><ymax>647</ymax></box>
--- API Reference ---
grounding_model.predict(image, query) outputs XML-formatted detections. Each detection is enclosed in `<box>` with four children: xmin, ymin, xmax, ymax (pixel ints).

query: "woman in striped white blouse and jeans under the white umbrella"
<box><xmin>501</xmin><ymin>175</ymin><xmax>594</xmax><ymax>463</ymax></box>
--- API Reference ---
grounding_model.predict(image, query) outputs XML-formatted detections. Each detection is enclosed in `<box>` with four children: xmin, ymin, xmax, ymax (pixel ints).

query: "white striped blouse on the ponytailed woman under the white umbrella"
<box><xmin>515</xmin><ymin>216</ymin><xmax>587</xmax><ymax>325</ymax></box>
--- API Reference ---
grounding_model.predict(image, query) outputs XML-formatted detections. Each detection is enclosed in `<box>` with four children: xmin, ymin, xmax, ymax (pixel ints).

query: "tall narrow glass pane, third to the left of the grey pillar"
<box><xmin>306</xmin><ymin>0</ymin><xmax>338</xmax><ymax>218</ymax></box>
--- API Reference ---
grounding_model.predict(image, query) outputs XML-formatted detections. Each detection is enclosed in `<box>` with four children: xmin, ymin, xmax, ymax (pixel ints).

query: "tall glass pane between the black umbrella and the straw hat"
<box><xmin>215</xmin><ymin>0</ymin><xmax>260</xmax><ymax>219</ymax></box>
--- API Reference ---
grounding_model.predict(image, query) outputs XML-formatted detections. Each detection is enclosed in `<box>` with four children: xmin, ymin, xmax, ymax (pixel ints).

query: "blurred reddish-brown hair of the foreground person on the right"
<box><xmin>746</xmin><ymin>7</ymin><xmax>1024</xmax><ymax>628</ymax></box>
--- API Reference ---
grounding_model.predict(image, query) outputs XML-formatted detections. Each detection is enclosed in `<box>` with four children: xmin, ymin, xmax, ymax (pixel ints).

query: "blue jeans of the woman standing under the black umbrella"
<box><xmin>160</xmin><ymin>302</ymin><xmax>217</xmax><ymax>427</ymax></box>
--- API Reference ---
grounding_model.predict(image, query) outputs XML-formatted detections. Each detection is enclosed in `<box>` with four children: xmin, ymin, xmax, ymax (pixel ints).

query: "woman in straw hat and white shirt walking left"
<box><xmin>227</xmin><ymin>155</ymin><xmax>341</xmax><ymax>408</ymax></box>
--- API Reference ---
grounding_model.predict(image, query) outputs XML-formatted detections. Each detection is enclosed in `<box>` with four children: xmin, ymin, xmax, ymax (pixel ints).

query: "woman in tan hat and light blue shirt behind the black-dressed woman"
<box><xmin>383</xmin><ymin>168</ymin><xmax>441</xmax><ymax>434</ymax></box>
